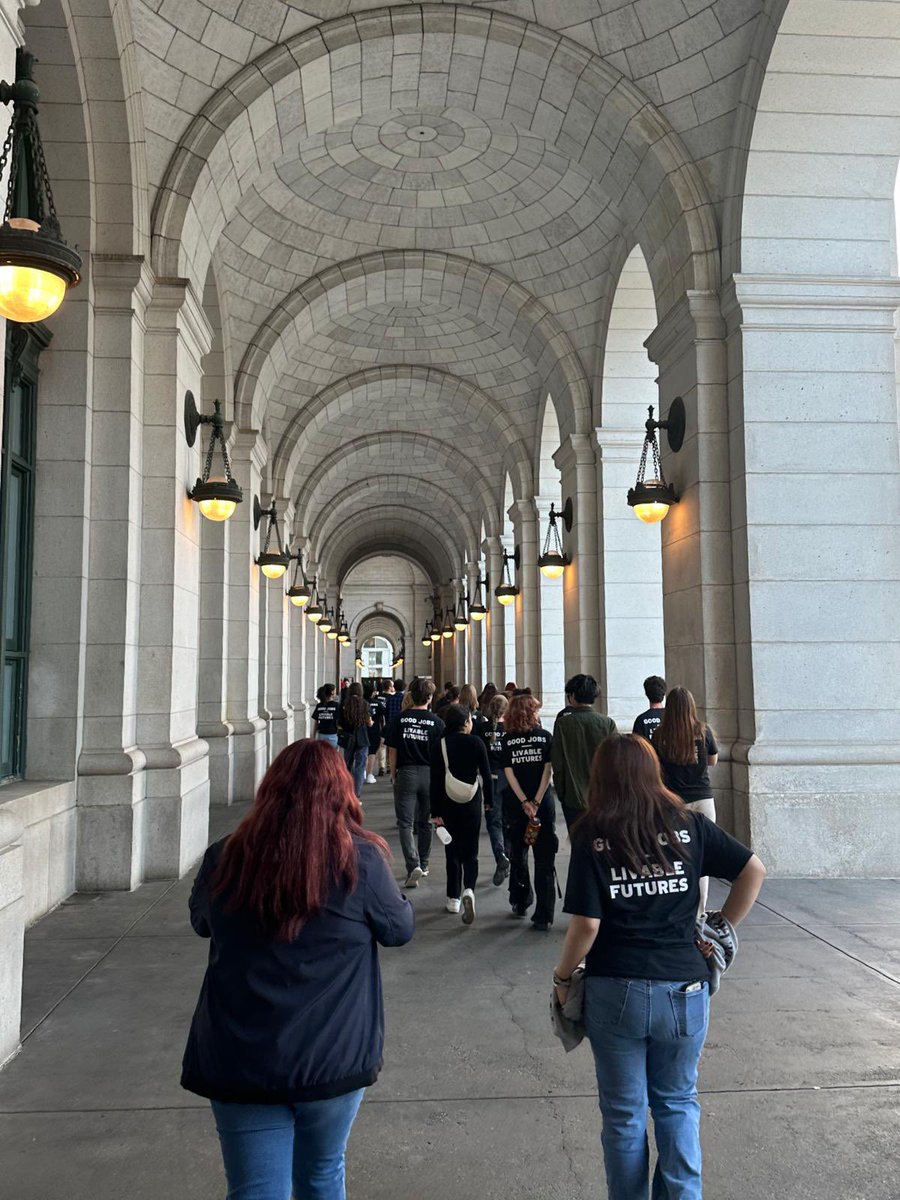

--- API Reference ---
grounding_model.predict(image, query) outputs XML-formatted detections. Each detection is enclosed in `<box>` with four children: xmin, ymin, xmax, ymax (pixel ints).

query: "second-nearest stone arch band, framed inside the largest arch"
<box><xmin>235</xmin><ymin>250</ymin><xmax>590</xmax><ymax>441</ymax></box>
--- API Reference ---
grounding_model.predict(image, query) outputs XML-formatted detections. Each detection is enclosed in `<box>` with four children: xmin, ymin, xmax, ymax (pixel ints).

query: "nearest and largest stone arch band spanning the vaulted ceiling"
<box><xmin>152</xmin><ymin>5</ymin><xmax>719</xmax><ymax>319</ymax></box>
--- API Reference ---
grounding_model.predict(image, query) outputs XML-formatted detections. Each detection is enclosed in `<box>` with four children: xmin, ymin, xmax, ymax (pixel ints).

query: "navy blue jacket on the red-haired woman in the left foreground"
<box><xmin>181</xmin><ymin>839</ymin><xmax>415</xmax><ymax>1104</ymax></box>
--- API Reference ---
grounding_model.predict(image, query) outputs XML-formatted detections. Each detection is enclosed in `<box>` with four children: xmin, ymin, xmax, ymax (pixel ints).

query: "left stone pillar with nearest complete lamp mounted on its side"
<box><xmin>137</xmin><ymin>281</ymin><xmax>211</xmax><ymax>878</ymax></box>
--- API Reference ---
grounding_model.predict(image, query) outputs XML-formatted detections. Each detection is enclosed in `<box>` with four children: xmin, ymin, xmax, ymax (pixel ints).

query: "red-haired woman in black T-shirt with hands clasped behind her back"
<box><xmin>500</xmin><ymin>695</ymin><xmax>559</xmax><ymax>932</ymax></box>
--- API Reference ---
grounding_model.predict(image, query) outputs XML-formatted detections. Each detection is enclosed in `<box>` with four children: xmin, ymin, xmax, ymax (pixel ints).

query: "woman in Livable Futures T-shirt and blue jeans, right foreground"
<box><xmin>553</xmin><ymin>733</ymin><xmax>766</xmax><ymax>1200</ymax></box>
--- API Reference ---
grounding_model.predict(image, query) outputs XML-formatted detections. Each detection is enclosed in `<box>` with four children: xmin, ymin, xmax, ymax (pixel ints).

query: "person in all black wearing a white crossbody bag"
<box><xmin>431</xmin><ymin>704</ymin><xmax>493</xmax><ymax>925</ymax></box>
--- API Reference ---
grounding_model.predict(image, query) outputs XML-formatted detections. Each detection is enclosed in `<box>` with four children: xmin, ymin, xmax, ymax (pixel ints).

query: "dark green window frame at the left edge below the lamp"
<box><xmin>0</xmin><ymin>322</ymin><xmax>49</xmax><ymax>782</ymax></box>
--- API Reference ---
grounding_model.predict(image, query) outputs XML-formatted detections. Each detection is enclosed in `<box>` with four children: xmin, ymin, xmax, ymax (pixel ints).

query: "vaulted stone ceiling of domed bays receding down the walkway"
<box><xmin>131</xmin><ymin>0</ymin><xmax>758</xmax><ymax>571</ymax></box>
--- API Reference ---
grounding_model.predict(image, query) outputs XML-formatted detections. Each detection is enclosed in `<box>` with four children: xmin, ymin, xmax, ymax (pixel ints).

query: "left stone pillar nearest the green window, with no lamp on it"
<box><xmin>72</xmin><ymin>256</ymin><xmax>151</xmax><ymax>890</ymax></box>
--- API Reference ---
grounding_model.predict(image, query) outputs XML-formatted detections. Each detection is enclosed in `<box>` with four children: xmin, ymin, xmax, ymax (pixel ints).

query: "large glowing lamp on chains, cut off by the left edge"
<box><xmin>0</xmin><ymin>47</ymin><xmax>82</xmax><ymax>324</ymax></box>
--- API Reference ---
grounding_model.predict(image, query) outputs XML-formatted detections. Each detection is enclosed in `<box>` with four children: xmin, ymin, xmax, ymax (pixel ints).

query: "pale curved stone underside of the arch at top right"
<box><xmin>722</xmin><ymin>0</ymin><xmax>900</xmax><ymax>278</ymax></box>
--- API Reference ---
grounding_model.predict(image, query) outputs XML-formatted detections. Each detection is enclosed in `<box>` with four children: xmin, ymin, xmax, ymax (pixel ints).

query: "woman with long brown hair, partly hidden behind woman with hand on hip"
<box><xmin>652</xmin><ymin>688</ymin><xmax>719</xmax><ymax>911</ymax></box>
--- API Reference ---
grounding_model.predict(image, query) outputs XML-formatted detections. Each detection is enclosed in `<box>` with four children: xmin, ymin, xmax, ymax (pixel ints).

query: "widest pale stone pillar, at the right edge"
<box><xmin>714</xmin><ymin>276</ymin><xmax>900</xmax><ymax>876</ymax></box>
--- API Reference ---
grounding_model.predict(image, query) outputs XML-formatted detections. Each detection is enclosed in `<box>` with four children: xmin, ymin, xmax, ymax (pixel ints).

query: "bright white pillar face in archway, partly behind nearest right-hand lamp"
<box><xmin>594</xmin><ymin>432</ymin><xmax>668</xmax><ymax>731</ymax></box>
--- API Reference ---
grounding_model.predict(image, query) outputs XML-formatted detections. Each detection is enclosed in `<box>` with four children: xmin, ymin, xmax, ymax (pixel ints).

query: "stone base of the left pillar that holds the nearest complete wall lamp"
<box><xmin>144</xmin><ymin>738</ymin><xmax>210</xmax><ymax>880</ymax></box>
